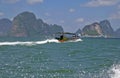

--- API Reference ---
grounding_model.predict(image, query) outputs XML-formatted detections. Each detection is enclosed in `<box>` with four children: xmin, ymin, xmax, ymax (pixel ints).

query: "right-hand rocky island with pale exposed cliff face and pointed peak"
<box><xmin>78</xmin><ymin>20</ymin><xmax>114</xmax><ymax>37</ymax></box>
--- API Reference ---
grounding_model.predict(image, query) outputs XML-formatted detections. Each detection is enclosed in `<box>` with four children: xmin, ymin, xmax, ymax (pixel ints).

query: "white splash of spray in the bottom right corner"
<box><xmin>109</xmin><ymin>64</ymin><xmax>120</xmax><ymax>78</ymax></box>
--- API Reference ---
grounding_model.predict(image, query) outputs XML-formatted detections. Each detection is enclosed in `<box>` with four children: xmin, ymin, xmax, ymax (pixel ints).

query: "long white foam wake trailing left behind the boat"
<box><xmin>0</xmin><ymin>39</ymin><xmax>59</xmax><ymax>46</ymax></box>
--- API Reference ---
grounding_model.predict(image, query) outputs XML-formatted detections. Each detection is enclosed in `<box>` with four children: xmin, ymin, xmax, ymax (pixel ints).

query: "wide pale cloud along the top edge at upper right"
<box><xmin>83</xmin><ymin>0</ymin><xmax>120</xmax><ymax>7</ymax></box>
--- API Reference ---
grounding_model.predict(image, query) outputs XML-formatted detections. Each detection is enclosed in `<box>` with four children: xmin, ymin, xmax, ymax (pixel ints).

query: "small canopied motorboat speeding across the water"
<box><xmin>55</xmin><ymin>32</ymin><xmax>80</xmax><ymax>42</ymax></box>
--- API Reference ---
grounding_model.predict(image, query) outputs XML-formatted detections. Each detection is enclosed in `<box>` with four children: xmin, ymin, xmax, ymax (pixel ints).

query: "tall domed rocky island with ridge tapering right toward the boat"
<box><xmin>10</xmin><ymin>12</ymin><xmax>63</xmax><ymax>37</ymax></box>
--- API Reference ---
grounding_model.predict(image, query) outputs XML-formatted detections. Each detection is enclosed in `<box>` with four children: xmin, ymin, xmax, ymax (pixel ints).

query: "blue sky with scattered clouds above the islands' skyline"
<box><xmin>0</xmin><ymin>0</ymin><xmax>120</xmax><ymax>32</ymax></box>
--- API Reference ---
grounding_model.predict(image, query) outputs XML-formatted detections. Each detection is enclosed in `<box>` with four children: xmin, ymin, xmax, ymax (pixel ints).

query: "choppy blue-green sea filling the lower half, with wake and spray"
<box><xmin>0</xmin><ymin>38</ymin><xmax>120</xmax><ymax>78</ymax></box>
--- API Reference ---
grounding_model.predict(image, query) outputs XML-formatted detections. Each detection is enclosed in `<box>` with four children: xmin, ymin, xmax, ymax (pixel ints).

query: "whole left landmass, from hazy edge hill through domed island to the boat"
<box><xmin>0</xmin><ymin>12</ymin><xmax>64</xmax><ymax>37</ymax></box>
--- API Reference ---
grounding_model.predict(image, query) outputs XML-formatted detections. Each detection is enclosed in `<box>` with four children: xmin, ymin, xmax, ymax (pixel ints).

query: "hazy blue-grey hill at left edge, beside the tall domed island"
<box><xmin>0</xmin><ymin>18</ymin><xmax>12</xmax><ymax>36</ymax></box>
